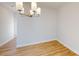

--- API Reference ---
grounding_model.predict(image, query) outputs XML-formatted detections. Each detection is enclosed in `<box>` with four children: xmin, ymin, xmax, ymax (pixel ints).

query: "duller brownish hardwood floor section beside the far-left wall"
<box><xmin>0</xmin><ymin>38</ymin><xmax>16</xmax><ymax>56</ymax></box>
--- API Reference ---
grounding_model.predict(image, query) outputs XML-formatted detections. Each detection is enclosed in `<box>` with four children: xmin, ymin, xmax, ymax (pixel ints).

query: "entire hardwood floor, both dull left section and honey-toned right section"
<box><xmin>0</xmin><ymin>40</ymin><xmax>77</xmax><ymax>56</ymax></box>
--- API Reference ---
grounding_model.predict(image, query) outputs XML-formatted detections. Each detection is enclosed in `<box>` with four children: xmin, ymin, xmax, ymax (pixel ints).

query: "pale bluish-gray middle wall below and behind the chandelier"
<box><xmin>15</xmin><ymin>7</ymin><xmax>56</xmax><ymax>46</ymax></box>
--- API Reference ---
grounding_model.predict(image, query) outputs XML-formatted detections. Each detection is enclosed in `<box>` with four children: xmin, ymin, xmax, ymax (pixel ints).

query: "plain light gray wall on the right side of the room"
<box><xmin>57</xmin><ymin>3</ymin><xmax>79</xmax><ymax>54</ymax></box>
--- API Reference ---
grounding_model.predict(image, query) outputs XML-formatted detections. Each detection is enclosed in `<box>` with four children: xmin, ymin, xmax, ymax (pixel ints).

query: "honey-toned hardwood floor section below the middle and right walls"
<box><xmin>16</xmin><ymin>40</ymin><xmax>77</xmax><ymax>56</ymax></box>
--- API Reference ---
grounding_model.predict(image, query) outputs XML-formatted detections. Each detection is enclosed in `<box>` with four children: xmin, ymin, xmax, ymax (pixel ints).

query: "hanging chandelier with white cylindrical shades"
<box><xmin>16</xmin><ymin>2</ymin><xmax>41</xmax><ymax>17</ymax></box>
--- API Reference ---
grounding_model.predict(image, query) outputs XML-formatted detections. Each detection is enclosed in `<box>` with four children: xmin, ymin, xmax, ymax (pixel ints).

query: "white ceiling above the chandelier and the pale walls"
<box><xmin>0</xmin><ymin>2</ymin><xmax>68</xmax><ymax>11</ymax></box>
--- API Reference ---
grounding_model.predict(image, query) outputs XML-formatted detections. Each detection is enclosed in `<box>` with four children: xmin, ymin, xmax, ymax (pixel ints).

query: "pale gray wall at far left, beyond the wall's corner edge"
<box><xmin>0</xmin><ymin>5</ymin><xmax>14</xmax><ymax>44</ymax></box>
